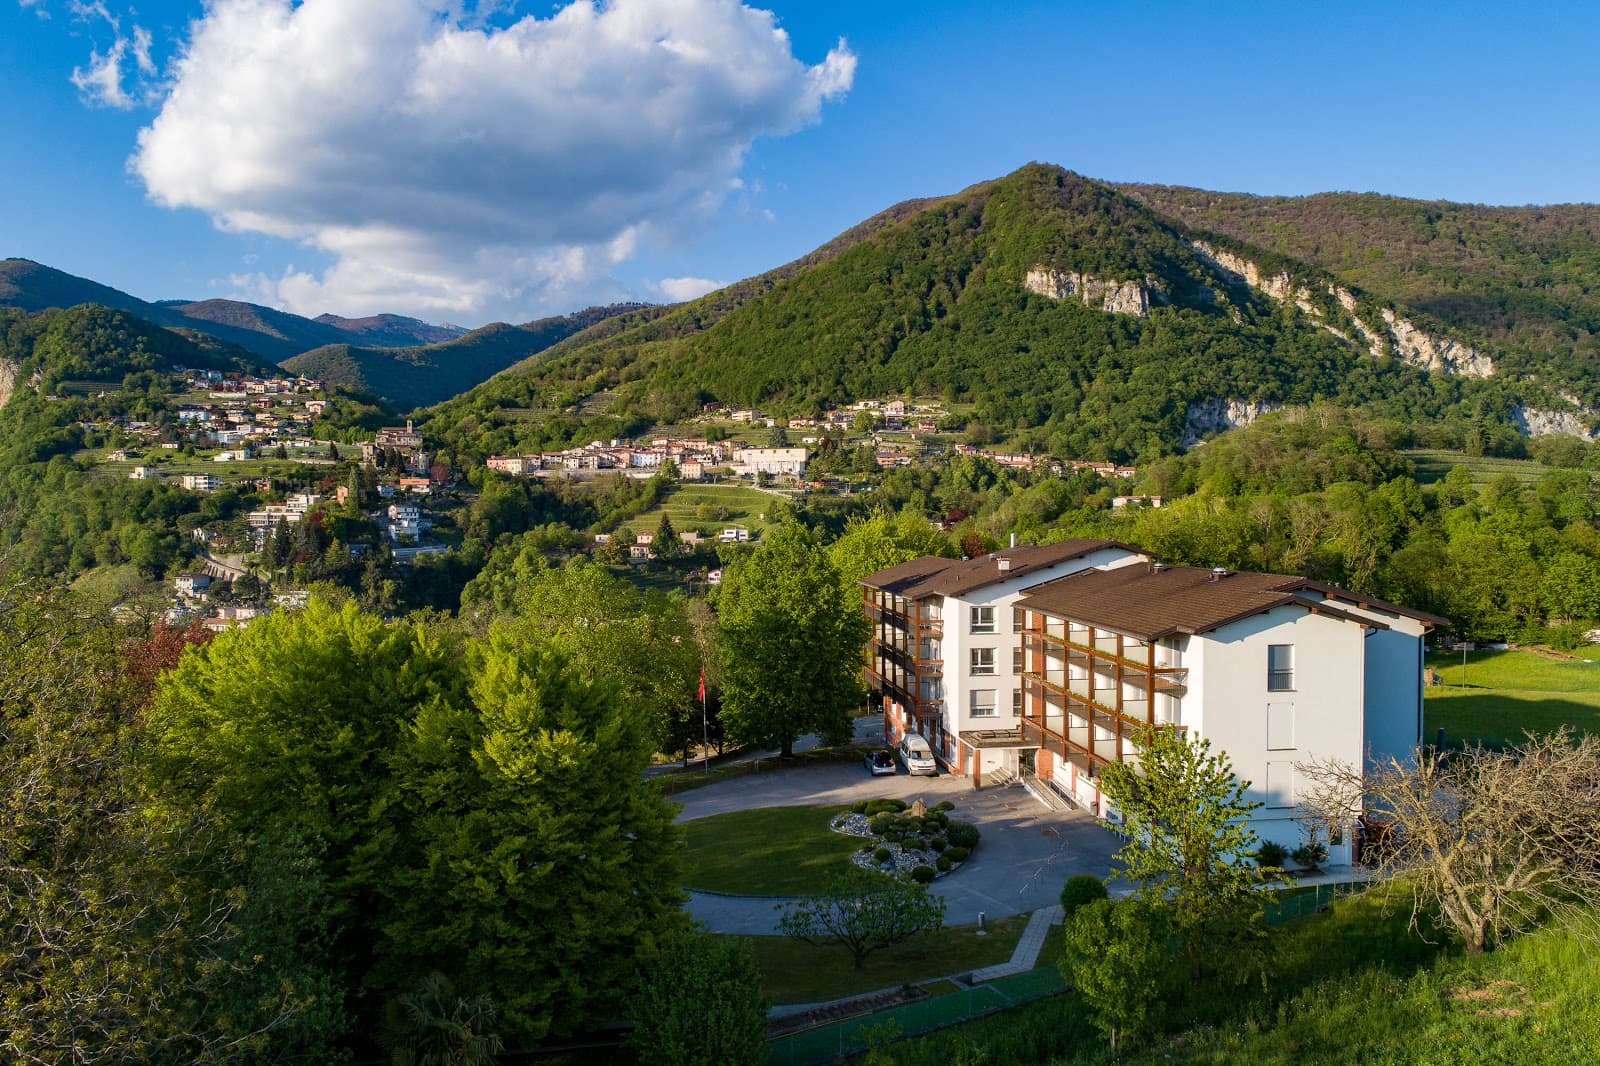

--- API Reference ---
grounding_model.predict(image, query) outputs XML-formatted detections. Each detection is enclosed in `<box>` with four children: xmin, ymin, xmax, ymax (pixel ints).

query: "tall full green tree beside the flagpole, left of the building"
<box><xmin>718</xmin><ymin>522</ymin><xmax>867</xmax><ymax>755</ymax></box>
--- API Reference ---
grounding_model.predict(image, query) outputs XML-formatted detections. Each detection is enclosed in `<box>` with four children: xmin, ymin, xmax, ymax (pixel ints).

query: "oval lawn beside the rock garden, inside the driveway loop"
<box><xmin>683</xmin><ymin>807</ymin><xmax>866</xmax><ymax>896</ymax></box>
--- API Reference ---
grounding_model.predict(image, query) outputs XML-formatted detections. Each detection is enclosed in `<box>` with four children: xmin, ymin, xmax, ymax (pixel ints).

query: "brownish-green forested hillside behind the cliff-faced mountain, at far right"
<box><xmin>1120</xmin><ymin>184</ymin><xmax>1600</xmax><ymax>407</ymax></box>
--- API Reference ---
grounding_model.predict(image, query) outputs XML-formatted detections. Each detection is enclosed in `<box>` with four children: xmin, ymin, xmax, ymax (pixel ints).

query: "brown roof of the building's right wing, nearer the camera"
<box><xmin>1018</xmin><ymin>565</ymin><xmax>1387</xmax><ymax>640</ymax></box>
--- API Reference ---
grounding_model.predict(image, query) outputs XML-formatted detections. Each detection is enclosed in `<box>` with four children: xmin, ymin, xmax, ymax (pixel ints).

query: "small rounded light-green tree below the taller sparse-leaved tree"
<box><xmin>1059</xmin><ymin>898</ymin><xmax>1171</xmax><ymax>1052</ymax></box>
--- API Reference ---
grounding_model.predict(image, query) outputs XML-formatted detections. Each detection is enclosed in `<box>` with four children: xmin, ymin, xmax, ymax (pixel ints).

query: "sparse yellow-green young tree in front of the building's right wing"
<box><xmin>1101</xmin><ymin>727</ymin><xmax>1261</xmax><ymax>978</ymax></box>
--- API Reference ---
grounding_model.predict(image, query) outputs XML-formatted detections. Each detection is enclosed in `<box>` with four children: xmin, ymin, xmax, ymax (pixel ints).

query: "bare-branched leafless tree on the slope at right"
<box><xmin>1299</xmin><ymin>730</ymin><xmax>1600</xmax><ymax>952</ymax></box>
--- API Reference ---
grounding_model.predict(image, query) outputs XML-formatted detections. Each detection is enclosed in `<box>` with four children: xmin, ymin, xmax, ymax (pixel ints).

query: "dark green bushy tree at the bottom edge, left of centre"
<box><xmin>629</xmin><ymin>933</ymin><xmax>766</xmax><ymax>1066</ymax></box>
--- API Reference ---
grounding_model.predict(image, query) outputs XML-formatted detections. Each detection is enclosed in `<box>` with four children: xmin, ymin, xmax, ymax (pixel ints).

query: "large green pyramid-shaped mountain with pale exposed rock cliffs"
<box><xmin>429</xmin><ymin>163</ymin><xmax>1600</xmax><ymax>459</ymax></box>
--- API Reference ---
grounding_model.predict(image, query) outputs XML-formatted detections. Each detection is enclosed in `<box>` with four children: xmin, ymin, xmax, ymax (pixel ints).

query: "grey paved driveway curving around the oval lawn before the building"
<box><xmin>678</xmin><ymin>763</ymin><xmax>1120</xmax><ymax>935</ymax></box>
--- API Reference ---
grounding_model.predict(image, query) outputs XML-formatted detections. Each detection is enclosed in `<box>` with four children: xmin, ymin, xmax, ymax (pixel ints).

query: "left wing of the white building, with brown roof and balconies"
<box><xmin>862</xmin><ymin>539</ymin><xmax>1144</xmax><ymax>784</ymax></box>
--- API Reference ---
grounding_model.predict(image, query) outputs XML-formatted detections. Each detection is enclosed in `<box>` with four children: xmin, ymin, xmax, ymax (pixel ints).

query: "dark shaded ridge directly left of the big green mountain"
<box><xmin>283</xmin><ymin>304</ymin><xmax>642</xmax><ymax>408</ymax></box>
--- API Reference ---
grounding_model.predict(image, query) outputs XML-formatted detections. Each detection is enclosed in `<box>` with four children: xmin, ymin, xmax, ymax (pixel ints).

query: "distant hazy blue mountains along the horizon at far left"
<box><xmin>0</xmin><ymin>259</ymin><xmax>462</xmax><ymax>362</ymax></box>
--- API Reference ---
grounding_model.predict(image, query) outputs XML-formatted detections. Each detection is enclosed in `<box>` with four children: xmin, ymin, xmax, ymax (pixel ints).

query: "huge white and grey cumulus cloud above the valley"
<box><xmin>130</xmin><ymin>0</ymin><xmax>856</xmax><ymax>320</ymax></box>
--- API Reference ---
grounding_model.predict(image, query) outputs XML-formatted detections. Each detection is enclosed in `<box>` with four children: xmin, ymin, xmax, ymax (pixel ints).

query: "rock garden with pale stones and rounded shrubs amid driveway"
<box><xmin>829</xmin><ymin>799</ymin><xmax>981</xmax><ymax>884</ymax></box>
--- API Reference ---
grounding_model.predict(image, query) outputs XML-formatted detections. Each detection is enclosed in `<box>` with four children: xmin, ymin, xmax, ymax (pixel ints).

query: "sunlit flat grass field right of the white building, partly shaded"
<box><xmin>1424</xmin><ymin>648</ymin><xmax>1600</xmax><ymax>743</ymax></box>
